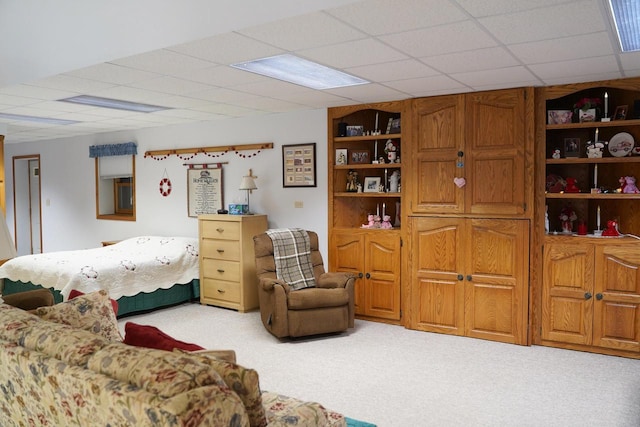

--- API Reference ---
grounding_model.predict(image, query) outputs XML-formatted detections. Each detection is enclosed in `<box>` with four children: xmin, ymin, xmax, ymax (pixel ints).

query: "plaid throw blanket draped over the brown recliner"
<box><xmin>267</xmin><ymin>228</ymin><xmax>316</xmax><ymax>291</ymax></box>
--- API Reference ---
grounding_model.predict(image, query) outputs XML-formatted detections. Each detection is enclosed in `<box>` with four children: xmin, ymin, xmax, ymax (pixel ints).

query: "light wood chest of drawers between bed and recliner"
<box><xmin>198</xmin><ymin>215</ymin><xmax>268</xmax><ymax>312</ymax></box>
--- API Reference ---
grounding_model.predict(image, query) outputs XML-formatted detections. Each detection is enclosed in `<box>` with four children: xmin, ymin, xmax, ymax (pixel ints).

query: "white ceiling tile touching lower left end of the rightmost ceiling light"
<box><xmin>509</xmin><ymin>31</ymin><xmax>614</xmax><ymax>64</ymax></box>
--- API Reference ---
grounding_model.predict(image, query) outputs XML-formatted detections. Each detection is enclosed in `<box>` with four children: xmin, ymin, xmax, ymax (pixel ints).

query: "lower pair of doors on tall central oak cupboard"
<box><xmin>408</xmin><ymin>217</ymin><xmax>529</xmax><ymax>344</ymax></box>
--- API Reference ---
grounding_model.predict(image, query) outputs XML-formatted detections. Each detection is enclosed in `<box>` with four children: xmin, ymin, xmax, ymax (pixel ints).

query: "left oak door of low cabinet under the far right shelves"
<box><xmin>541</xmin><ymin>244</ymin><xmax>594</xmax><ymax>345</ymax></box>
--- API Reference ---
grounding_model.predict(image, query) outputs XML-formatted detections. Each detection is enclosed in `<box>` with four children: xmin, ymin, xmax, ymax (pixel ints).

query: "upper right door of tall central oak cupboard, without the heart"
<box><xmin>464</xmin><ymin>89</ymin><xmax>527</xmax><ymax>215</ymax></box>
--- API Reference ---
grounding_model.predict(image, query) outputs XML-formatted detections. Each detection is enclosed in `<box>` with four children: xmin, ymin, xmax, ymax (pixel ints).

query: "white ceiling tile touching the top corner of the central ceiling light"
<box><xmin>239</xmin><ymin>12</ymin><xmax>366</xmax><ymax>51</ymax></box>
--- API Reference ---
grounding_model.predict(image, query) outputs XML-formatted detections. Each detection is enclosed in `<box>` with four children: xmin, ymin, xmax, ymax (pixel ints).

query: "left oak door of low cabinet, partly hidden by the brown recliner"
<box><xmin>329</xmin><ymin>230</ymin><xmax>365</xmax><ymax>314</ymax></box>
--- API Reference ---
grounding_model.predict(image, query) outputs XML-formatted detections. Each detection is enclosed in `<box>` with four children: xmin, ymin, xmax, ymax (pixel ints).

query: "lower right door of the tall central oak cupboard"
<box><xmin>465</xmin><ymin>219</ymin><xmax>529</xmax><ymax>344</ymax></box>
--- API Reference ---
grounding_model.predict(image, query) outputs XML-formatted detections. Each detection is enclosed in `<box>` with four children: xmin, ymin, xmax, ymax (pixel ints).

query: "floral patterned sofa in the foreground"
<box><xmin>0</xmin><ymin>292</ymin><xmax>345</xmax><ymax>427</ymax></box>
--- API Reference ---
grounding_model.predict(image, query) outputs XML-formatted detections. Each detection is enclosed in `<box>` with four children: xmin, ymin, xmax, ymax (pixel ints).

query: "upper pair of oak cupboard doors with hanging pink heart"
<box><xmin>404</xmin><ymin>88</ymin><xmax>533</xmax><ymax>216</ymax></box>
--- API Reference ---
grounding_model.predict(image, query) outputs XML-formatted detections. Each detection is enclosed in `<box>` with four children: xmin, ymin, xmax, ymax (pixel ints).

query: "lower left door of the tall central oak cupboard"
<box><xmin>410</xmin><ymin>218</ymin><xmax>465</xmax><ymax>335</ymax></box>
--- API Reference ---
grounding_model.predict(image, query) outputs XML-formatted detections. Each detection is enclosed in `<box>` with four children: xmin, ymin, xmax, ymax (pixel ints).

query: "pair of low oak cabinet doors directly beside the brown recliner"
<box><xmin>330</xmin><ymin>229</ymin><xmax>401</xmax><ymax>323</ymax></box>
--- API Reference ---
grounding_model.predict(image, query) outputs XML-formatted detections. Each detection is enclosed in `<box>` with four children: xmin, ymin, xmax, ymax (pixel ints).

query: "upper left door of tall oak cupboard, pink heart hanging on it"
<box><xmin>410</xmin><ymin>95</ymin><xmax>464</xmax><ymax>214</ymax></box>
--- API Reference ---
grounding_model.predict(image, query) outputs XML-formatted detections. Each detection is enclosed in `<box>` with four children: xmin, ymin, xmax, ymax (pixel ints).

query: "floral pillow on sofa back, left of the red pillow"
<box><xmin>35</xmin><ymin>290</ymin><xmax>122</xmax><ymax>342</ymax></box>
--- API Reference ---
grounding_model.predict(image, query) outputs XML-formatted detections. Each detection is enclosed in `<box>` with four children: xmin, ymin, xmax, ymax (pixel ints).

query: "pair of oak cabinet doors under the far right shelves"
<box><xmin>541</xmin><ymin>236</ymin><xmax>640</xmax><ymax>358</ymax></box>
